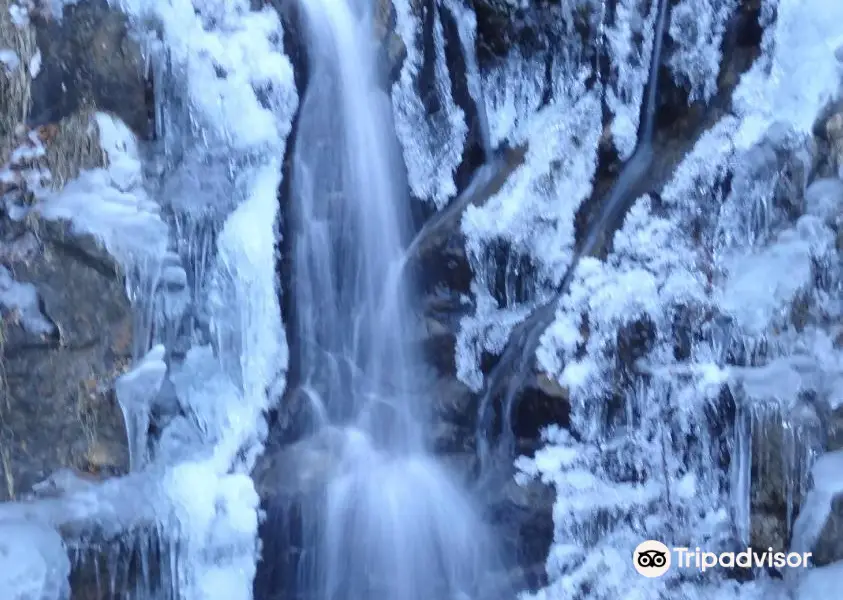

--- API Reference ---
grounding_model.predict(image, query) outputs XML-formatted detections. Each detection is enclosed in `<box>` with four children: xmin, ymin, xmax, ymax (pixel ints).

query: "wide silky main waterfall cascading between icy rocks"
<box><xmin>291</xmin><ymin>0</ymin><xmax>505</xmax><ymax>600</ymax></box>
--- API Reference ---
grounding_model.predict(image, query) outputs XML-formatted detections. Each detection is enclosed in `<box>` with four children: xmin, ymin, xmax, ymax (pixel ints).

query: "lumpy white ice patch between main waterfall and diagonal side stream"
<box><xmin>457</xmin><ymin>84</ymin><xmax>601</xmax><ymax>389</ymax></box>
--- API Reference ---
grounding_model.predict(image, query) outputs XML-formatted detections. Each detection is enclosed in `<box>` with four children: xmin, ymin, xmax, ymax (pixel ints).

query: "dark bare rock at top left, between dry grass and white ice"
<box><xmin>30</xmin><ymin>0</ymin><xmax>153</xmax><ymax>138</ymax></box>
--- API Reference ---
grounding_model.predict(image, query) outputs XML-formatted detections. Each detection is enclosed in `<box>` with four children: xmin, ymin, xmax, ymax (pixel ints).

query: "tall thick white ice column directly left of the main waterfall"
<box><xmin>4</xmin><ymin>0</ymin><xmax>298</xmax><ymax>600</ymax></box>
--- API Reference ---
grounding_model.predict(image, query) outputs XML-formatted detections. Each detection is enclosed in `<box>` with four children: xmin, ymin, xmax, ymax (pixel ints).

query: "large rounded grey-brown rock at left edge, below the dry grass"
<box><xmin>0</xmin><ymin>220</ymin><xmax>132</xmax><ymax>500</ymax></box>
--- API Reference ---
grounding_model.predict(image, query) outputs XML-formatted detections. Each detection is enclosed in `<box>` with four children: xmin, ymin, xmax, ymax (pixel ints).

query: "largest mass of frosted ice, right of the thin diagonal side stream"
<box><xmin>498</xmin><ymin>0</ymin><xmax>843</xmax><ymax>600</ymax></box>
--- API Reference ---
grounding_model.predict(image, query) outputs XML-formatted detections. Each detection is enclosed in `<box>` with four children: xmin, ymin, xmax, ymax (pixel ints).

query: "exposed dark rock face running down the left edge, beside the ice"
<box><xmin>0</xmin><ymin>0</ymin><xmax>151</xmax><ymax>500</ymax></box>
